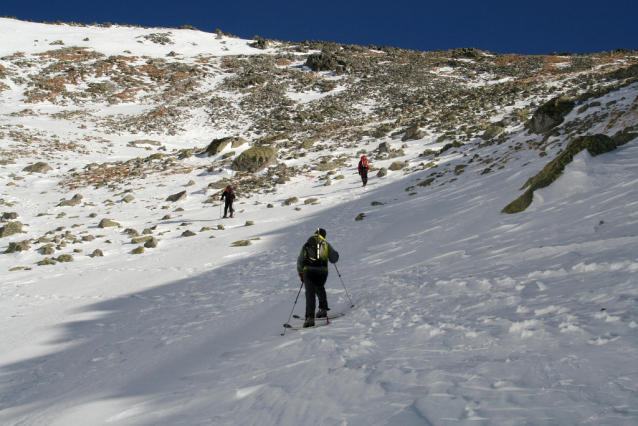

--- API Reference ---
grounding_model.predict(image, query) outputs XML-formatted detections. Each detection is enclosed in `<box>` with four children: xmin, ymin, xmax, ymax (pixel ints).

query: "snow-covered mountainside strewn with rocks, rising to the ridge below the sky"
<box><xmin>0</xmin><ymin>19</ymin><xmax>638</xmax><ymax>425</ymax></box>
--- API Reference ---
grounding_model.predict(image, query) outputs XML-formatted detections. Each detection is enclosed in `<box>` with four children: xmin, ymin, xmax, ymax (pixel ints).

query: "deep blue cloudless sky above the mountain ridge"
<box><xmin>0</xmin><ymin>0</ymin><xmax>638</xmax><ymax>54</ymax></box>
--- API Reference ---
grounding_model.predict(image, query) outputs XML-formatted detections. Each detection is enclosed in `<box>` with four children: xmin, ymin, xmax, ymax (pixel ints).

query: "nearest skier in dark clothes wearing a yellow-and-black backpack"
<box><xmin>297</xmin><ymin>228</ymin><xmax>339</xmax><ymax>328</ymax></box>
